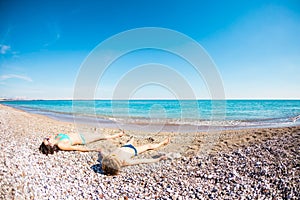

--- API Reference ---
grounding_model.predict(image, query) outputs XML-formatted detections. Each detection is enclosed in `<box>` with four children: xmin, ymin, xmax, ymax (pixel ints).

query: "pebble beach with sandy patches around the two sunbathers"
<box><xmin>0</xmin><ymin>105</ymin><xmax>300</xmax><ymax>199</ymax></box>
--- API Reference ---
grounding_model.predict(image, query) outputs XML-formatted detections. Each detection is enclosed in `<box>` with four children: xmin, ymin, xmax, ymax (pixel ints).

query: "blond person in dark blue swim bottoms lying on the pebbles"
<box><xmin>102</xmin><ymin>138</ymin><xmax>170</xmax><ymax>175</ymax></box>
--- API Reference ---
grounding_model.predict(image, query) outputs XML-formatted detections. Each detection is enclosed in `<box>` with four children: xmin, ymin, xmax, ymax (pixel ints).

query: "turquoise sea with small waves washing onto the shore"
<box><xmin>0</xmin><ymin>100</ymin><xmax>300</xmax><ymax>132</ymax></box>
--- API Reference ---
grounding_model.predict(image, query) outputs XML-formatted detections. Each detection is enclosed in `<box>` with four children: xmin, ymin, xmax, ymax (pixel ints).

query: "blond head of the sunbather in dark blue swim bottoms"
<box><xmin>102</xmin><ymin>155</ymin><xmax>122</xmax><ymax>175</ymax></box>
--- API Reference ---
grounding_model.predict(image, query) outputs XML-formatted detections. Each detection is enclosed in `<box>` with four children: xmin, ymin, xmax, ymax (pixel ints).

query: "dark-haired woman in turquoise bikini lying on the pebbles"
<box><xmin>39</xmin><ymin>131</ymin><xmax>124</xmax><ymax>155</ymax></box>
